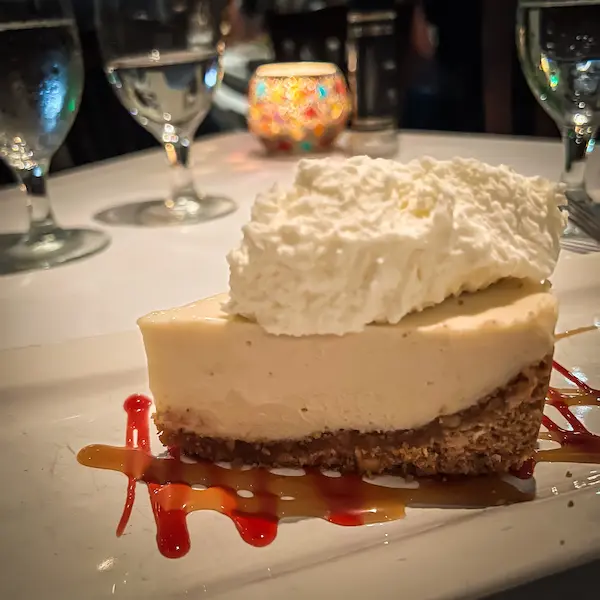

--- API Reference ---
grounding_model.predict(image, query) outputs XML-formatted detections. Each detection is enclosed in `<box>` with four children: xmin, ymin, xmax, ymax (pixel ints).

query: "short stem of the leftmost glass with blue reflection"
<box><xmin>18</xmin><ymin>161</ymin><xmax>59</xmax><ymax>244</ymax></box>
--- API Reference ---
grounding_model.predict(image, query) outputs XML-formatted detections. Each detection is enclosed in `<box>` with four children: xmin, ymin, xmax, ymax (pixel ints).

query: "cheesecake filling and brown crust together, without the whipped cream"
<box><xmin>139</xmin><ymin>279</ymin><xmax>557</xmax><ymax>475</ymax></box>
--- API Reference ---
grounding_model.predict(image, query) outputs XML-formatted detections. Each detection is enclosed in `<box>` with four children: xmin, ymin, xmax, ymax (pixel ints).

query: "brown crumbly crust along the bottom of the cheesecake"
<box><xmin>154</xmin><ymin>355</ymin><xmax>552</xmax><ymax>475</ymax></box>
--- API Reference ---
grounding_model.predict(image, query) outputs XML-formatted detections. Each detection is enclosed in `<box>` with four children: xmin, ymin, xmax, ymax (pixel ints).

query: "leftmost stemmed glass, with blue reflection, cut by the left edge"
<box><xmin>0</xmin><ymin>0</ymin><xmax>109</xmax><ymax>274</ymax></box>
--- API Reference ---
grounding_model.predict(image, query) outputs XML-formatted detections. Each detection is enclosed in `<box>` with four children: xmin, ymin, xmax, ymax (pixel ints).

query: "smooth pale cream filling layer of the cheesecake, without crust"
<box><xmin>139</xmin><ymin>280</ymin><xmax>557</xmax><ymax>441</ymax></box>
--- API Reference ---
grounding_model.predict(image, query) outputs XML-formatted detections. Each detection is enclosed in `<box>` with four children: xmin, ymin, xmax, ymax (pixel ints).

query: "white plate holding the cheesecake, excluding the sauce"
<box><xmin>0</xmin><ymin>255</ymin><xmax>600</xmax><ymax>600</ymax></box>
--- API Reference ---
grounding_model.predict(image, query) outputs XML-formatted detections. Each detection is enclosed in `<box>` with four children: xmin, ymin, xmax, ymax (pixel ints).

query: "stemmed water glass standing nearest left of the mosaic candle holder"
<box><xmin>96</xmin><ymin>0</ymin><xmax>236</xmax><ymax>226</ymax></box>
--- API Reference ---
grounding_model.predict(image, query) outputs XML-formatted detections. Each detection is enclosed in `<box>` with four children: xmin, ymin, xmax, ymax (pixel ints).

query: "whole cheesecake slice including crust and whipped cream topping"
<box><xmin>139</xmin><ymin>157</ymin><xmax>565</xmax><ymax>474</ymax></box>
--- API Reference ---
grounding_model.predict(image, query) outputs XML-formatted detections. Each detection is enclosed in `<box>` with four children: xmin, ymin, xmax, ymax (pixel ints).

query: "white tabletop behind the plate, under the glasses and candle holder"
<box><xmin>0</xmin><ymin>131</ymin><xmax>600</xmax><ymax>598</ymax></box>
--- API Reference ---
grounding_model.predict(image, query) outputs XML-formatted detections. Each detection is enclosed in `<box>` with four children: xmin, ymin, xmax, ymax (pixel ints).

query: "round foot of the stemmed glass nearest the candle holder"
<box><xmin>94</xmin><ymin>196</ymin><xmax>237</xmax><ymax>227</ymax></box>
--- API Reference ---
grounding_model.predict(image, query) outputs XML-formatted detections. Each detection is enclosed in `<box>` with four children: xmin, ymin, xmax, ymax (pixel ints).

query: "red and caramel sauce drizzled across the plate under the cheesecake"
<box><xmin>77</xmin><ymin>326</ymin><xmax>600</xmax><ymax>558</ymax></box>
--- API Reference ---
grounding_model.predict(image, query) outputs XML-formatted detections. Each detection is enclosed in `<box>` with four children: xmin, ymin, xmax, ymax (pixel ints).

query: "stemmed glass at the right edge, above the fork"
<box><xmin>516</xmin><ymin>0</ymin><xmax>600</xmax><ymax>203</ymax></box>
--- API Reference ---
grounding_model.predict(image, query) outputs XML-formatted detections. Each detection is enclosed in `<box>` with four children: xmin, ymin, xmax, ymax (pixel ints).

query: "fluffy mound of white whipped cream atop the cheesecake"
<box><xmin>224</xmin><ymin>156</ymin><xmax>566</xmax><ymax>336</ymax></box>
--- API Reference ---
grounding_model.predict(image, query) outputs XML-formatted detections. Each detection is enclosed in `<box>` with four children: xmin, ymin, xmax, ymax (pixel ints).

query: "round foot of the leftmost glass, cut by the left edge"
<box><xmin>0</xmin><ymin>229</ymin><xmax>110</xmax><ymax>275</ymax></box>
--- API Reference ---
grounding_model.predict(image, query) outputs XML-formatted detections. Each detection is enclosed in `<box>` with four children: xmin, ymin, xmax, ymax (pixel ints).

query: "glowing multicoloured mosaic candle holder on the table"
<box><xmin>248</xmin><ymin>62</ymin><xmax>350</xmax><ymax>153</ymax></box>
